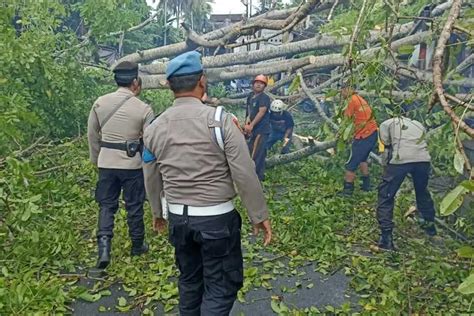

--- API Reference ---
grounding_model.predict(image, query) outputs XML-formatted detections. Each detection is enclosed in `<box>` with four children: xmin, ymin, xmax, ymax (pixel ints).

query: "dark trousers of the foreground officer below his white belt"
<box><xmin>169</xmin><ymin>206</ymin><xmax>243</xmax><ymax>316</ymax></box>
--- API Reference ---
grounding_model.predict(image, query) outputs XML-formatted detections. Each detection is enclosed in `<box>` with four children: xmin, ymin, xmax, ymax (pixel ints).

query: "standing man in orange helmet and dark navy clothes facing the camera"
<box><xmin>244</xmin><ymin>75</ymin><xmax>270</xmax><ymax>181</ymax></box>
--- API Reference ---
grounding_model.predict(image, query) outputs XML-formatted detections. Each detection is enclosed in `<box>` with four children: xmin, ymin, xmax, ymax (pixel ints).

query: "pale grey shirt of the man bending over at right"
<box><xmin>379</xmin><ymin>116</ymin><xmax>431</xmax><ymax>164</ymax></box>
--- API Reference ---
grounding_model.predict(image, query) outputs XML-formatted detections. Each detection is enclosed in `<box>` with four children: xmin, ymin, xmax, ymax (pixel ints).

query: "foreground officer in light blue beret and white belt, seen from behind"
<box><xmin>144</xmin><ymin>51</ymin><xmax>272</xmax><ymax>316</ymax></box>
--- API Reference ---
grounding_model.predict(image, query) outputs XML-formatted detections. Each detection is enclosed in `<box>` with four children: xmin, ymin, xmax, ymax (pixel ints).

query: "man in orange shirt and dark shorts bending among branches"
<box><xmin>340</xmin><ymin>85</ymin><xmax>378</xmax><ymax>196</ymax></box>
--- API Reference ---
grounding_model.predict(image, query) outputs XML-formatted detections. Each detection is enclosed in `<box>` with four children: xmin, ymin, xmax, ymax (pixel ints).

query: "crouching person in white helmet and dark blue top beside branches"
<box><xmin>267</xmin><ymin>100</ymin><xmax>295</xmax><ymax>154</ymax></box>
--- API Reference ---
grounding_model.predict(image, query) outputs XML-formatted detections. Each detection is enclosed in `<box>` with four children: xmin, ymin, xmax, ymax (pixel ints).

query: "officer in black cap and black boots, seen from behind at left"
<box><xmin>87</xmin><ymin>62</ymin><xmax>153</xmax><ymax>269</ymax></box>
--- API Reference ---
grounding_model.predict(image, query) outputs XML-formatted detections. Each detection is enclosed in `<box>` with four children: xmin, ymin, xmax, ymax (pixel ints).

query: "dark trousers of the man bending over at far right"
<box><xmin>377</xmin><ymin>162</ymin><xmax>435</xmax><ymax>231</ymax></box>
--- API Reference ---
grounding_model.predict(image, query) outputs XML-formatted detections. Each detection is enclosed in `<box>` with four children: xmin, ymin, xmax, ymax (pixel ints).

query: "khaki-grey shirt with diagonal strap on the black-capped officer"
<box><xmin>87</xmin><ymin>87</ymin><xmax>154</xmax><ymax>169</ymax></box>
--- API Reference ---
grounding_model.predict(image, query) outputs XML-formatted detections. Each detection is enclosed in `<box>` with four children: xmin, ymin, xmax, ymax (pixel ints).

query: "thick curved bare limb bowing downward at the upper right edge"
<box><xmin>433</xmin><ymin>0</ymin><xmax>474</xmax><ymax>138</ymax></box>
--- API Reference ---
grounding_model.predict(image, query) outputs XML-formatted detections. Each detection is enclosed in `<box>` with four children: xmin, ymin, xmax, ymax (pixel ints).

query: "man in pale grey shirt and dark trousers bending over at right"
<box><xmin>377</xmin><ymin>111</ymin><xmax>436</xmax><ymax>250</ymax></box>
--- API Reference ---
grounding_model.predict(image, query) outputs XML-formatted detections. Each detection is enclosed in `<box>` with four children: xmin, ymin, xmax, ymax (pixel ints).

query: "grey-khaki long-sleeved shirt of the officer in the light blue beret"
<box><xmin>143</xmin><ymin>97</ymin><xmax>268</xmax><ymax>224</ymax></box>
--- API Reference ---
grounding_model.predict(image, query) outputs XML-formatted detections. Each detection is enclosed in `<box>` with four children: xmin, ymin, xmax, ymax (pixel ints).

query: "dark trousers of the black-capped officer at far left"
<box><xmin>95</xmin><ymin>168</ymin><xmax>145</xmax><ymax>241</ymax></box>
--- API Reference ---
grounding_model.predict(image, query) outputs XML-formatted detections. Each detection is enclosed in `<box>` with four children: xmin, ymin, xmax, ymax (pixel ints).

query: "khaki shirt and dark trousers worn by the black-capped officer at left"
<box><xmin>87</xmin><ymin>88</ymin><xmax>153</xmax><ymax>254</ymax></box>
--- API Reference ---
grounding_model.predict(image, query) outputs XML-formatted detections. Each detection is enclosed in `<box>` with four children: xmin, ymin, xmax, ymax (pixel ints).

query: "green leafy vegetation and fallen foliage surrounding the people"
<box><xmin>0</xmin><ymin>0</ymin><xmax>474</xmax><ymax>315</ymax></box>
